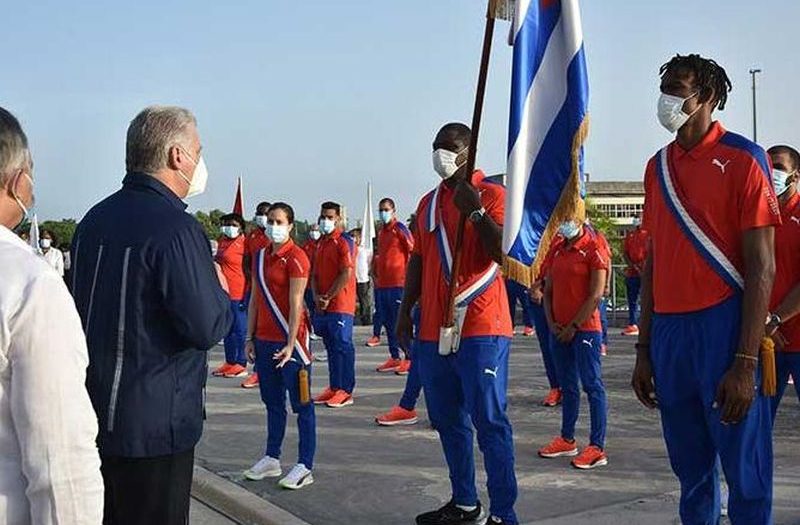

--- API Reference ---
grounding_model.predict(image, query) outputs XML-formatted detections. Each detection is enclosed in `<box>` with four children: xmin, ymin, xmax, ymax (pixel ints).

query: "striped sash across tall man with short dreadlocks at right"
<box><xmin>656</xmin><ymin>147</ymin><xmax>744</xmax><ymax>292</ymax></box>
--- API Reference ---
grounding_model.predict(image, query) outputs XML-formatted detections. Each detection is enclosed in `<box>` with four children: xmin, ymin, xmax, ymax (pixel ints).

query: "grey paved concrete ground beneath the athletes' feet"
<box><xmin>197</xmin><ymin>328</ymin><xmax>800</xmax><ymax>525</ymax></box>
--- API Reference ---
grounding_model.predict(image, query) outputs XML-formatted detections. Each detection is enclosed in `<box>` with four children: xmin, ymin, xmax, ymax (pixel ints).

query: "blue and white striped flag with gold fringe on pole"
<box><xmin>503</xmin><ymin>0</ymin><xmax>589</xmax><ymax>285</ymax></box>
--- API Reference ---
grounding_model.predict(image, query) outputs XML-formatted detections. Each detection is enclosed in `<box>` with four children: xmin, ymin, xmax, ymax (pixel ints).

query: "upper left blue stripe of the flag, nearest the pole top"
<box><xmin>508</xmin><ymin>0</ymin><xmax>561</xmax><ymax>149</ymax></box>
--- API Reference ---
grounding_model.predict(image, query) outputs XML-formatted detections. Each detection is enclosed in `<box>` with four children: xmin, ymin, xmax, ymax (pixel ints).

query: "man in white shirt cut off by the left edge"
<box><xmin>0</xmin><ymin>108</ymin><xmax>103</xmax><ymax>525</ymax></box>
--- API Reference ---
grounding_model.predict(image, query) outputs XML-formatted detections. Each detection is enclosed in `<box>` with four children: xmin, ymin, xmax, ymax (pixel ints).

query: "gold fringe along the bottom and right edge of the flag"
<box><xmin>503</xmin><ymin>115</ymin><xmax>589</xmax><ymax>288</ymax></box>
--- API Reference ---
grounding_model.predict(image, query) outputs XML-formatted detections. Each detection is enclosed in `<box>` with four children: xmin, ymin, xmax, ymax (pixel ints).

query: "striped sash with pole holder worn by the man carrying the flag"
<box><xmin>426</xmin><ymin>184</ymin><xmax>500</xmax><ymax>355</ymax></box>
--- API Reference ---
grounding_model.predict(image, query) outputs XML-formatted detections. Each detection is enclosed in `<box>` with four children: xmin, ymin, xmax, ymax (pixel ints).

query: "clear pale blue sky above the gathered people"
<box><xmin>0</xmin><ymin>0</ymin><xmax>800</xmax><ymax>224</ymax></box>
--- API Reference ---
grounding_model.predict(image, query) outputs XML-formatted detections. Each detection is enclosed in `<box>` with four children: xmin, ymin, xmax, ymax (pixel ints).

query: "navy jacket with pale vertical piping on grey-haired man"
<box><xmin>71</xmin><ymin>173</ymin><xmax>232</xmax><ymax>458</ymax></box>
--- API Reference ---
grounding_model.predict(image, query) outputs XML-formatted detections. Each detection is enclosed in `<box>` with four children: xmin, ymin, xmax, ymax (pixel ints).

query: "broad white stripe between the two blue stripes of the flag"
<box><xmin>503</xmin><ymin>0</ymin><xmax>583</xmax><ymax>253</ymax></box>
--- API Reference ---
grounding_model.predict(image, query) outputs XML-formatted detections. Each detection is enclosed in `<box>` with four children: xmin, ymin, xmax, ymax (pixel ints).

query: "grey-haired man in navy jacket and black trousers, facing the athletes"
<box><xmin>72</xmin><ymin>107</ymin><xmax>231</xmax><ymax>525</ymax></box>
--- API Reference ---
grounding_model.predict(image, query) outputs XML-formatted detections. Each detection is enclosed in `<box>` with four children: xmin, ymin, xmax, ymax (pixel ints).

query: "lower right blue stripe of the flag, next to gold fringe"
<box><xmin>508</xmin><ymin>46</ymin><xmax>589</xmax><ymax>265</ymax></box>
